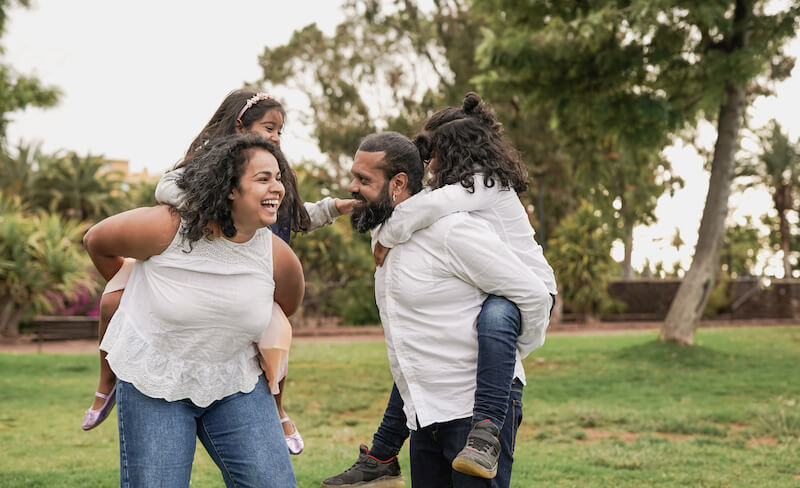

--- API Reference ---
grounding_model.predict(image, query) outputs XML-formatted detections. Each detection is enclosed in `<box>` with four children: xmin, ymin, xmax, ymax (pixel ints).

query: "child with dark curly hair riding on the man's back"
<box><xmin>323</xmin><ymin>93</ymin><xmax>557</xmax><ymax>487</ymax></box>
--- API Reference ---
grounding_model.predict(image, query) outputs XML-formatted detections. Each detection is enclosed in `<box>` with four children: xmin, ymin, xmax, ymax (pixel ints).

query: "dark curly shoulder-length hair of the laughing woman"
<box><xmin>177</xmin><ymin>134</ymin><xmax>289</xmax><ymax>246</ymax></box>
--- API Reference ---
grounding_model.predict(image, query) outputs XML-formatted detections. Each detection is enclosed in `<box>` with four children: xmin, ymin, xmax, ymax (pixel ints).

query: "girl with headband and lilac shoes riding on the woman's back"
<box><xmin>82</xmin><ymin>88</ymin><xmax>353</xmax><ymax>454</ymax></box>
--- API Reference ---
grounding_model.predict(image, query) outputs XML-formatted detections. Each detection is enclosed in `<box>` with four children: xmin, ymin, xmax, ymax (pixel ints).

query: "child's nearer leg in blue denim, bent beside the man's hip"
<box><xmin>472</xmin><ymin>295</ymin><xmax>521</xmax><ymax>429</ymax></box>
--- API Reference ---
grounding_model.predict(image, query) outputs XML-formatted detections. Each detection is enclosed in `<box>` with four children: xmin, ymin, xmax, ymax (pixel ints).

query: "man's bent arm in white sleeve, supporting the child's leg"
<box><xmin>444</xmin><ymin>215</ymin><xmax>552</xmax><ymax>358</ymax></box>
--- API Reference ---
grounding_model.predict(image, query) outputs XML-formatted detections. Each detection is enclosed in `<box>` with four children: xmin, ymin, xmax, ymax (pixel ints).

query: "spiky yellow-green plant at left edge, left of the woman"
<box><xmin>0</xmin><ymin>193</ymin><xmax>96</xmax><ymax>335</ymax></box>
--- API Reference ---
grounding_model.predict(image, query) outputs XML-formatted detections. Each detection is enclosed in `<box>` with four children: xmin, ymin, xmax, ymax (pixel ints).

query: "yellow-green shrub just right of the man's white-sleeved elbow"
<box><xmin>548</xmin><ymin>201</ymin><xmax>619</xmax><ymax>316</ymax></box>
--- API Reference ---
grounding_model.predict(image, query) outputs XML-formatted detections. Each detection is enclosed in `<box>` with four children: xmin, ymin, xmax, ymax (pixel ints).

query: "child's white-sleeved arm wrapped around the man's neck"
<box><xmin>378</xmin><ymin>178</ymin><xmax>511</xmax><ymax>248</ymax></box>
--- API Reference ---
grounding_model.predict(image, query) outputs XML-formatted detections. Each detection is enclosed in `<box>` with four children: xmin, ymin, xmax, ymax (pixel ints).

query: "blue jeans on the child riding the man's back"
<box><xmin>370</xmin><ymin>295</ymin><xmax>521</xmax><ymax>459</ymax></box>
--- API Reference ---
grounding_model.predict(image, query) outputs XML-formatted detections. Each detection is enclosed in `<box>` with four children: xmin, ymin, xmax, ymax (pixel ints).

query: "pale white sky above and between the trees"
<box><xmin>6</xmin><ymin>0</ymin><xmax>800</xmax><ymax>275</ymax></box>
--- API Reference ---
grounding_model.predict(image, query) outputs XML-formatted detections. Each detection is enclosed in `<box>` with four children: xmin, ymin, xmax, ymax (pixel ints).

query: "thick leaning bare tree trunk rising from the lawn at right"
<box><xmin>660</xmin><ymin>82</ymin><xmax>745</xmax><ymax>345</ymax></box>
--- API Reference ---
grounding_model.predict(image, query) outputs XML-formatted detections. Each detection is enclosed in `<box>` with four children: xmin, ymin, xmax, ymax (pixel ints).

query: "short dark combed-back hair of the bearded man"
<box><xmin>358</xmin><ymin>131</ymin><xmax>425</xmax><ymax>195</ymax></box>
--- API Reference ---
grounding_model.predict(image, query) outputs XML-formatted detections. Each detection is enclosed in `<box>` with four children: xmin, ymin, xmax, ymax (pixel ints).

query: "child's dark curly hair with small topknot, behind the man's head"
<box><xmin>414</xmin><ymin>92</ymin><xmax>528</xmax><ymax>193</ymax></box>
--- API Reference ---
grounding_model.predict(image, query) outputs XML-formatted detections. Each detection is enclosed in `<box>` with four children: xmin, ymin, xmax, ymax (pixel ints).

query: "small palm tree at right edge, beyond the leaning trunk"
<box><xmin>737</xmin><ymin>119</ymin><xmax>800</xmax><ymax>278</ymax></box>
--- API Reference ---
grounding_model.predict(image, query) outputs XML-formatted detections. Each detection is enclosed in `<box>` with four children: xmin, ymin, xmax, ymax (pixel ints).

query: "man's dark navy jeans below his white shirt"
<box><xmin>411</xmin><ymin>380</ymin><xmax>522</xmax><ymax>488</ymax></box>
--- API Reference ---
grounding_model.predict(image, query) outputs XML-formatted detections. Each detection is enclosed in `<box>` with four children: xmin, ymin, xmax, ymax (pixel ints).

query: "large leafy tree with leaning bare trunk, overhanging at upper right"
<box><xmin>476</xmin><ymin>0</ymin><xmax>800</xmax><ymax>345</ymax></box>
